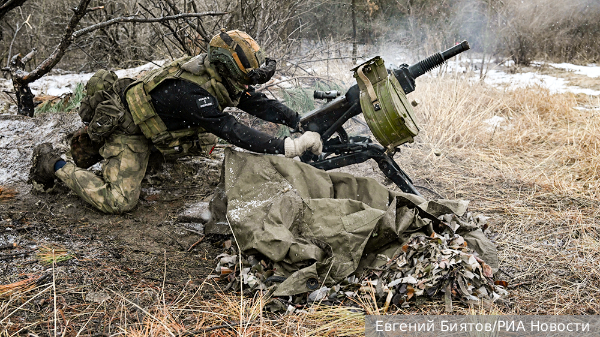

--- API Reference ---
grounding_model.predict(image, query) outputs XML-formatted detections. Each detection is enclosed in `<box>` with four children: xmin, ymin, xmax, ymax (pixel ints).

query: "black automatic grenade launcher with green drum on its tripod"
<box><xmin>300</xmin><ymin>41</ymin><xmax>470</xmax><ymax>195</ymax></box>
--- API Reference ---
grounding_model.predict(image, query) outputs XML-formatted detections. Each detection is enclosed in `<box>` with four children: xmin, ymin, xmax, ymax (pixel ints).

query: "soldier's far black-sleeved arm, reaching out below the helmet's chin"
<box><xmin>237</xmin><ymin>87</ymin><xmax>300</xmax><ymax>128</ymax></box>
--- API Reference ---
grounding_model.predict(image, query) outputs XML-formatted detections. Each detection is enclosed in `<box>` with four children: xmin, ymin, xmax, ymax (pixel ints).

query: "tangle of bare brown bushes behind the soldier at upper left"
<box><xmin>0</xmin><ymin>0</ymin><xmax>310</xmax><ymax>71</ymax></box>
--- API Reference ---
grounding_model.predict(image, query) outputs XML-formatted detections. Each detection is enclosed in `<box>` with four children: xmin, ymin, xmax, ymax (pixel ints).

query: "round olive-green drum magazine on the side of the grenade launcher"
<box><xmin>352</xmin><ymin>56</ymin><xmax>419</xmax><ymax>152</ymax></box>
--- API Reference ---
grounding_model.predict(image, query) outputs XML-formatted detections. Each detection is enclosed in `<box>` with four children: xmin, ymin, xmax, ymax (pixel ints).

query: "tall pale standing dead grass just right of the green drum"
<box><xmin>413</xmin><ymin>76</ymin><xmax>600</xmax><ymax>196</ymax></box>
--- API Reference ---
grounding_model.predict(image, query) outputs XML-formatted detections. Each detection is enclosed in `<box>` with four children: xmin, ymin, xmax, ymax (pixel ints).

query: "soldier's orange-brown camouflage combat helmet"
<box><xmin>208</xmin><ymin>29</ymin><xmax>276</xmax><ymax>84</ymax></box>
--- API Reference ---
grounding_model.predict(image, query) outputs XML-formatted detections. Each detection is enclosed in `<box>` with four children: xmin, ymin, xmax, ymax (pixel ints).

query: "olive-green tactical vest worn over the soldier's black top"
<box><xmin>125</xmin><ymin>54</ymin><xmax>239</xmax><ymax>156</ymax></box>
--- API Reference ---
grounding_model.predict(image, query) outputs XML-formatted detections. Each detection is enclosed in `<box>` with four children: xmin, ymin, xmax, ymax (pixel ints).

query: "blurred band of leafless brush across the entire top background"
<box><xmin>0</xmin><ymin>0</ymin><xmax>600</xmax><ymax>71</ymax></box>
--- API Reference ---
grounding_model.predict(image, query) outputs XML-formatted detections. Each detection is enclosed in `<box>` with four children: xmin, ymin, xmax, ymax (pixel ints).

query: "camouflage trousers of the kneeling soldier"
<box><xmin>56</xmin><ymin>133</ymin><xmax>150</xmax><ymax>214</ymax></box>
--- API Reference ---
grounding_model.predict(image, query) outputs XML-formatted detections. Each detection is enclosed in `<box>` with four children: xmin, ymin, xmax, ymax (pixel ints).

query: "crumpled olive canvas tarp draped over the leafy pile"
<box><xmin>206</xmin><ymin>149</ymin><xmax>498</xmax><ymax>296</ymax></box>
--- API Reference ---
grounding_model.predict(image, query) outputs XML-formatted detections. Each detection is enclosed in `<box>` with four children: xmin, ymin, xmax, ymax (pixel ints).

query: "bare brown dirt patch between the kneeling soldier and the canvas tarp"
<box><xmin>0</xmin><ymin>151</ymin><xmax>224</xmax><ymax>284</ymax></box>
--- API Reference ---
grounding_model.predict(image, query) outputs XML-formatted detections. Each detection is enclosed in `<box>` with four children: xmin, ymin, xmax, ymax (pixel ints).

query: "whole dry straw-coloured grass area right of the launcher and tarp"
<box><xmin>402</xmin><ymin>72</ymin><xmax>600</xmax><ymax>314</ymax></box>
